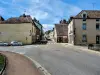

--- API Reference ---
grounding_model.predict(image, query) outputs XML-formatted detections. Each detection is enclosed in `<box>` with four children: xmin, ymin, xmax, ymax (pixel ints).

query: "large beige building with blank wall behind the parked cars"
<box><xmin>0</xmin><ymin>14</ymin><xmax>42</xmax><ymax>44</ymax></box>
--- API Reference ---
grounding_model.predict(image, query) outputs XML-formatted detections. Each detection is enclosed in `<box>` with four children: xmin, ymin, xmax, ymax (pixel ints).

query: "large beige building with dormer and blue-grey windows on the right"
<box><xmin>68</xmin><ymin>10</ymin><xmax>100</xmax><ymax>45</ymax></box>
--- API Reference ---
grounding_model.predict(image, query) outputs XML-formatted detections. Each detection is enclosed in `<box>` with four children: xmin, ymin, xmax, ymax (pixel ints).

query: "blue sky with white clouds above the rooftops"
<box><xmin>0</xmin><ymin>0</ymin><xmax>100</xmax><ymax>31</ymax></box>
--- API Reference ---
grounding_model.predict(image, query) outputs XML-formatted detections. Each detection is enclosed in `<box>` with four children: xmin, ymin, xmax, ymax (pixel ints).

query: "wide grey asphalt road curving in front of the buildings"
<box><xmin>0</xmin><ymin>42</ymin><xmax>100</xmax><ymax>75</ymax></box>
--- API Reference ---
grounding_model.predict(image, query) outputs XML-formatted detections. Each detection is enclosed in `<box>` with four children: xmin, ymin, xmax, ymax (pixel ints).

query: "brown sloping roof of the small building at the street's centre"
<box><xmin>55</xmin><ymin>24</ymin><xmax>68</xmax><ymax>36</ymax></box>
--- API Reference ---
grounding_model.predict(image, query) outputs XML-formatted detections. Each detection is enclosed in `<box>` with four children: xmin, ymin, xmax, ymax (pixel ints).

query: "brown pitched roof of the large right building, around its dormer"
<box><xmin>73</xmin><ymin>10</ymin><xmax>100</xmax><ymax>18</ymax></box>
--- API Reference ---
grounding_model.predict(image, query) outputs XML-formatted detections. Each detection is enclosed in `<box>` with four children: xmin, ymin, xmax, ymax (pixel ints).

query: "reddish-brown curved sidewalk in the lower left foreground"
<box><xmin>0</xmin><ymin>52</ymin><xmax>41</xmax><ymax>75</ymax></box>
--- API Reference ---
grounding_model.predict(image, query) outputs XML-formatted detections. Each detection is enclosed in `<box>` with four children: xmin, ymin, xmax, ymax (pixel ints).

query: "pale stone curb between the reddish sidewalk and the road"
<box><xmin>25</xmin><ymin>55</ymin><xmax>51</xmax><ymax>75</ymax></box>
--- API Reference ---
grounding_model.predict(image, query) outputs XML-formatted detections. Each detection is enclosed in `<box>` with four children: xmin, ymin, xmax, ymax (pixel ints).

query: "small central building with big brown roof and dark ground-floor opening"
<box><xmin>53</xmin><ymin>20</ymin><xmax>68</xmax><ymax>43</ymax></box>
